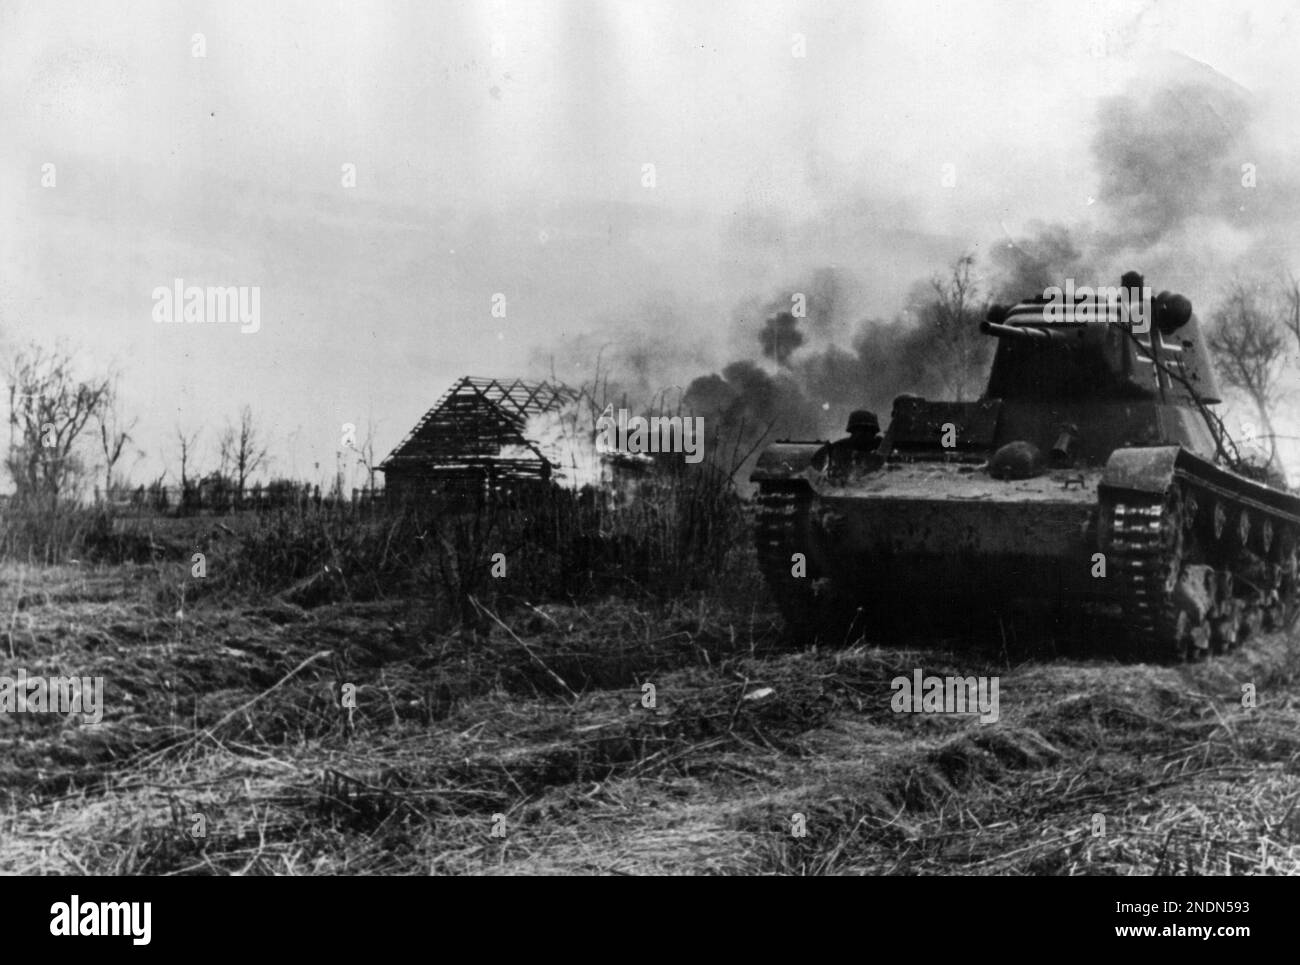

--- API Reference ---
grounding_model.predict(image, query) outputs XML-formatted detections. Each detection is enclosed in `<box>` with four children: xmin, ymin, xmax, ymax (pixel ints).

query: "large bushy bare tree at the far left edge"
<box><xmin>8</xmin><ymin>345</ymin><xmax>112</xmax><ymax>501</ymax></box>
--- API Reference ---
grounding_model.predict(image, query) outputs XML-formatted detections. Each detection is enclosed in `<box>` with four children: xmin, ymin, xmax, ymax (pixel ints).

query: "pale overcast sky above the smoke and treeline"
<box><xmin>0</xmin><ymin>0</ymin><xmax>1300</xmax><ymax>483</ymax></box>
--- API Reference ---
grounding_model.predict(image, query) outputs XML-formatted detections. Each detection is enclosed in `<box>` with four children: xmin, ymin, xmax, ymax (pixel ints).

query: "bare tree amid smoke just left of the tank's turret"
<box><xmin>911</xmin><ymin>254</ymin><xmax>989</xmax><ymax>402</ymax></box>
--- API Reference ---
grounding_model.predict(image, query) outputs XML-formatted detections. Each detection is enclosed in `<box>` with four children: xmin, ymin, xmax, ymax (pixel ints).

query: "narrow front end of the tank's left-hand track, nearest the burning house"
<box><xmin>754</xmin><ymin>480</ymin><xmax>816</xmax><ymax>629</ymax></box>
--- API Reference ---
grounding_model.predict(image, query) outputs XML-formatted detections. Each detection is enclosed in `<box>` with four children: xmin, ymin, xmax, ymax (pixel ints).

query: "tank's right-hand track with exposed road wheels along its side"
<box><xmin>1101</xmin><ymin>476</ymin><xmax>1300</xmax><ymax>662</ymax></box>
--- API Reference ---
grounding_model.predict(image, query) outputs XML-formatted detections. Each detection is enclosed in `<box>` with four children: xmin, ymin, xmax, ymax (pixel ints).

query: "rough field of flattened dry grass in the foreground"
<box><xmin>0</xmin><ymin>548</ymin><xmax>1300</xmax><ymax>874</ymax></box>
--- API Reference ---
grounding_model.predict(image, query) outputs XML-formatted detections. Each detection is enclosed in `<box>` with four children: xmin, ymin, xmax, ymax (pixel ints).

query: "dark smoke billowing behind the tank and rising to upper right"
<box><xmin>551</xmin><ymin>64</ymin><xmax>1300</xmax><ymax>481</ymax></box>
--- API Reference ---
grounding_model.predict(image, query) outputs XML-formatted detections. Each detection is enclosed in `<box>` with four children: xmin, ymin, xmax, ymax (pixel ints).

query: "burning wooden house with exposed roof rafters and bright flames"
<box><xmin>380</xmin><ymin>376</ymin><xmax>646</xmax><ymax>501</ymax></box>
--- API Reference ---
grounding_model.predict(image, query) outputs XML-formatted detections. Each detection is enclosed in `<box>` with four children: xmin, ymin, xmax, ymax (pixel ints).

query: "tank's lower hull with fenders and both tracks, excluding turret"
<box><xmin>755</xmin><ymin>443</ymin><xmax>1300</xmax><ymax>659</ymax></box>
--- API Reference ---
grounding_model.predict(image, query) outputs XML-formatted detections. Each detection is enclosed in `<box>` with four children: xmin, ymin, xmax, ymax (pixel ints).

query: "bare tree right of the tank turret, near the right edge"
<box><xmin>1208</xmin><ymin>281</ymin><xmax>1288</xmax><ymax>463</ymax></box>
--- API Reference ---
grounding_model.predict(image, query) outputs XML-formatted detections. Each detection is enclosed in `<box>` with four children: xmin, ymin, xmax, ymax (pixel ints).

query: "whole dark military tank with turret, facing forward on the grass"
<box><xmin>751</xmin><ymin>273</ymin><xmax>1300</xmax><ymax>662</ymax></box>
